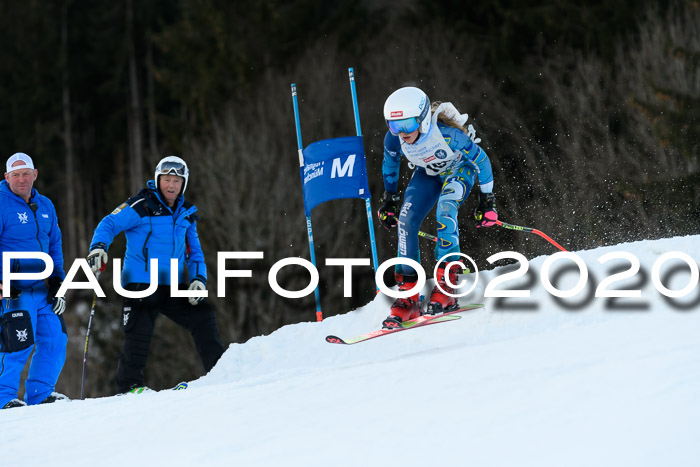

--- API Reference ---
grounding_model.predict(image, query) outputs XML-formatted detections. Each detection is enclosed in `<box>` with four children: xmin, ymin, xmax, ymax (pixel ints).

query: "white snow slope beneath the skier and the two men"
<box><xmin>0</xmin><ymin>236</ymin><xmax>700</xmax><ymax>466</ymax></box>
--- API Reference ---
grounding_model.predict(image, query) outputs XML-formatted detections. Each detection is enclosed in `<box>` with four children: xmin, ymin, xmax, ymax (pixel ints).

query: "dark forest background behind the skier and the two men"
<box><xmin>0</xmin><ymin>0</ymin><xmax>700</xmax><ymax>397</ymax></box>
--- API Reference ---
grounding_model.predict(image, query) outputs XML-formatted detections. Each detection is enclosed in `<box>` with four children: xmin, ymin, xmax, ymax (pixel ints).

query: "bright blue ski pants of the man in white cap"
<box><xmin>0</xmin><ymin>285</ymin><xmax>68</xmax><ymax>407</ymax></box>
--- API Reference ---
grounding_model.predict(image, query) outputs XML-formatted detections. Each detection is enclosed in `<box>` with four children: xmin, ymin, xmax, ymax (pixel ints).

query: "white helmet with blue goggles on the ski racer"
<box><xmin>384</xmin><ymin>87</ymin><xmax>431</xmax><ymax>135</ymax></box>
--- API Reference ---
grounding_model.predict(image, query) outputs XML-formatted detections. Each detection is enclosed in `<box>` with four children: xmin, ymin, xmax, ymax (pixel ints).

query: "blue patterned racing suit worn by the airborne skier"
<box><xmin>382</xmin><ymin>122</ymin><xmax>493</xmax><ymax>274</ymax></box>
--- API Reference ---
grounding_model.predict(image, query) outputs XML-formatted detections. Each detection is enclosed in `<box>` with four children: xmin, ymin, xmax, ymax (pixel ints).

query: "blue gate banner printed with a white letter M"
<box><xmin>301</xmin><ymin>136</ymin><xmax>370</xmax><ymax>216</ymax></box>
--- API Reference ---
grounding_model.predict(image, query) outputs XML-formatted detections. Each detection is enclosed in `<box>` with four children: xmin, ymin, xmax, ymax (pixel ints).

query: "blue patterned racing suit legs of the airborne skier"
<box><xmin>396</xmin><ymin>167</ymin><xmax>476</xmax><ymax>274</ymax></box>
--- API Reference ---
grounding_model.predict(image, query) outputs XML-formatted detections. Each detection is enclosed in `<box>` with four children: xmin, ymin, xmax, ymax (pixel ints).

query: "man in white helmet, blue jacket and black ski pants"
<box><xmin>88</xmin><ymin>156</ymin><xmax>224</xmax><ymax>393</ymax></box>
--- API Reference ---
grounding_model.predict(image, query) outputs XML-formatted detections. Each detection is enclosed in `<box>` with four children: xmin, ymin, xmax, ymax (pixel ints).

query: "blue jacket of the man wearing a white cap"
<box><xmin>0</xmin><ymin>180</ymin><xmax>66</xmax><ymax>290</ymax></box>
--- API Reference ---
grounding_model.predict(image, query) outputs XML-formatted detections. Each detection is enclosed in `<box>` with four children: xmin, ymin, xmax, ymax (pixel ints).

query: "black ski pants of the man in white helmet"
<box><xmin>117</xmin><ymin>284</ymin><xmax>225</xmax><ymax>393</ymax></box>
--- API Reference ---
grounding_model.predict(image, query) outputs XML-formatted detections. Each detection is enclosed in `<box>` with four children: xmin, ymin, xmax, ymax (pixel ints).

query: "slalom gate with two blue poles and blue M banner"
<box><xmin>292</xmin><ymin>68</ymin><xmax>377</xmax><ymax>321</ymax></box>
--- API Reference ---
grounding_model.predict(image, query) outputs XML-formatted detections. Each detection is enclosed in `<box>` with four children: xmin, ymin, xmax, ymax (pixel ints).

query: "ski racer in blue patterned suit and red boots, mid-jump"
<box><xmin>378</xmin><ymin>87</ymin><xmax>498</xmax><ymax>327</ymax></box>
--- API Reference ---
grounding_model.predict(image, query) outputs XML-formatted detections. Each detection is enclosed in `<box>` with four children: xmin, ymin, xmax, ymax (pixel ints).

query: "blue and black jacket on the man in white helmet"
<box><xmin>90</xmin><ymin>180</ymin><xmax>207</xmax><ymax>287</ymax></box>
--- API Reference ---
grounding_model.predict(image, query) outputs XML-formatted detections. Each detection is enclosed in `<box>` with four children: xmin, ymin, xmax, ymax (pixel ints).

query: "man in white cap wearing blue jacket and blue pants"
<box><xmin>0</xmin><ymin>153</ymin><xmax>68</xmax><ymax>409</ymax></box>
